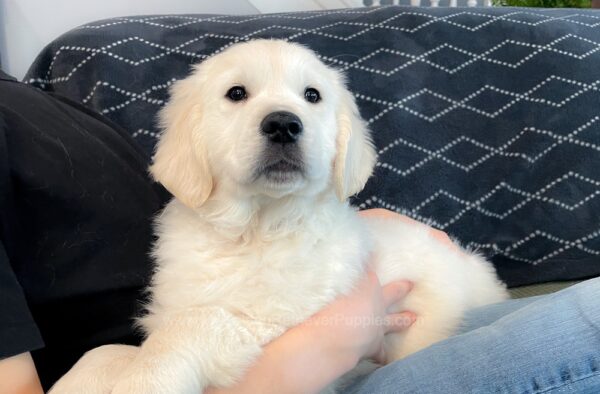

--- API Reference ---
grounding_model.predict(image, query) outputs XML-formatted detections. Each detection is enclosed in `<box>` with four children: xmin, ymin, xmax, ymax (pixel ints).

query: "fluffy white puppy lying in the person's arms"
<box><xmin>52</xmin><ymin>40</ymin><xmax>506</xmax><ymax>394</ymax></box>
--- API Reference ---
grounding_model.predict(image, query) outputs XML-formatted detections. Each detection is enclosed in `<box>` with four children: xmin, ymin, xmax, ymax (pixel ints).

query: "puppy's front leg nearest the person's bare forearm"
<box><xmin>112</xmin><ymin>307</ymin><xmax>261</xmax><ymax>394</ymax></box>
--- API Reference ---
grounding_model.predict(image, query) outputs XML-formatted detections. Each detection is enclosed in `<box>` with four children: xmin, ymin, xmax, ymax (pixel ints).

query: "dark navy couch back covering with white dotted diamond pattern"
<box><xmin>26</xmin><ymin>7</ymin><xmax>600</xmax><ymax>286</ymax></box>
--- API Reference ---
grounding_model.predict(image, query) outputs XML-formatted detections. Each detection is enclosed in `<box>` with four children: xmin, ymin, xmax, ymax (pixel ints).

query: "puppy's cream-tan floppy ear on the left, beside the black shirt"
<box><xmin>150</xmin><ymin>76</ymin><xmax>213</xmax><ymax>208</ymax></box>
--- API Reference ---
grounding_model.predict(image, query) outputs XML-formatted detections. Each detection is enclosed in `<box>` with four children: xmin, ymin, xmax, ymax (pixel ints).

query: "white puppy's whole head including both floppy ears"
<box><xmin>151</xmin><ymin>40</ymin><xmax>376</xmax><ymax>208</ymax></box>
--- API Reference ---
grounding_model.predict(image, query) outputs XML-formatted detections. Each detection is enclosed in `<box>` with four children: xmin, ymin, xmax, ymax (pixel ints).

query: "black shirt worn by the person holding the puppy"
<box><xmin>0</xmin><ymin>72</ymin><xmax>169</xmax><ymax>389</ymax></box>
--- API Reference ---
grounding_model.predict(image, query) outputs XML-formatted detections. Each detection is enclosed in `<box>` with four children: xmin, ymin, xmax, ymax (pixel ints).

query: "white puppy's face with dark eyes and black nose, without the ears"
<box><xmin>198</xmin><ymin>41</ymin><xmax>340</xmax><ymax>196</ymax></box>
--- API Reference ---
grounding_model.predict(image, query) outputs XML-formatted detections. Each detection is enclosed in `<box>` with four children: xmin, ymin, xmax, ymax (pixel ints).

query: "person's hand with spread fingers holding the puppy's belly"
<box><xmin>302</xmin><ymin>270</ymin><xmax>416</xmax><ymax>364</ymax></box>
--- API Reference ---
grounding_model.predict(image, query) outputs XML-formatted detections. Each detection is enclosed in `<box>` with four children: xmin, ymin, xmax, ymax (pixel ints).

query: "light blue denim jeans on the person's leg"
<box><xmin>346</xmin><ymin>278</ymin><xmax>600</xmax><ymax>394</ymax></box>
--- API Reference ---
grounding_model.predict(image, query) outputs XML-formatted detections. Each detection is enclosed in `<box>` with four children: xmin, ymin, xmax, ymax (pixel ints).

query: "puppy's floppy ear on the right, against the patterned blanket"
<box><xmin>333</xmin><ymin>88</ymin><xmax>377</xmax><ymax>201</ymax></box>
